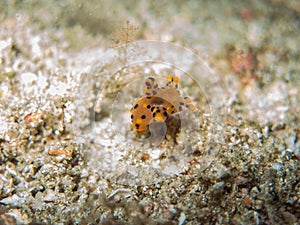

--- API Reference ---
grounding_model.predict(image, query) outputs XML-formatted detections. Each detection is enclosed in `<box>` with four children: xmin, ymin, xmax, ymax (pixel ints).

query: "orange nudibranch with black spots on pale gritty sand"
<box><xmin>130</xmin><ymin>76</ymin><xmax>195</xmax><ymax>132</ymax></box>
